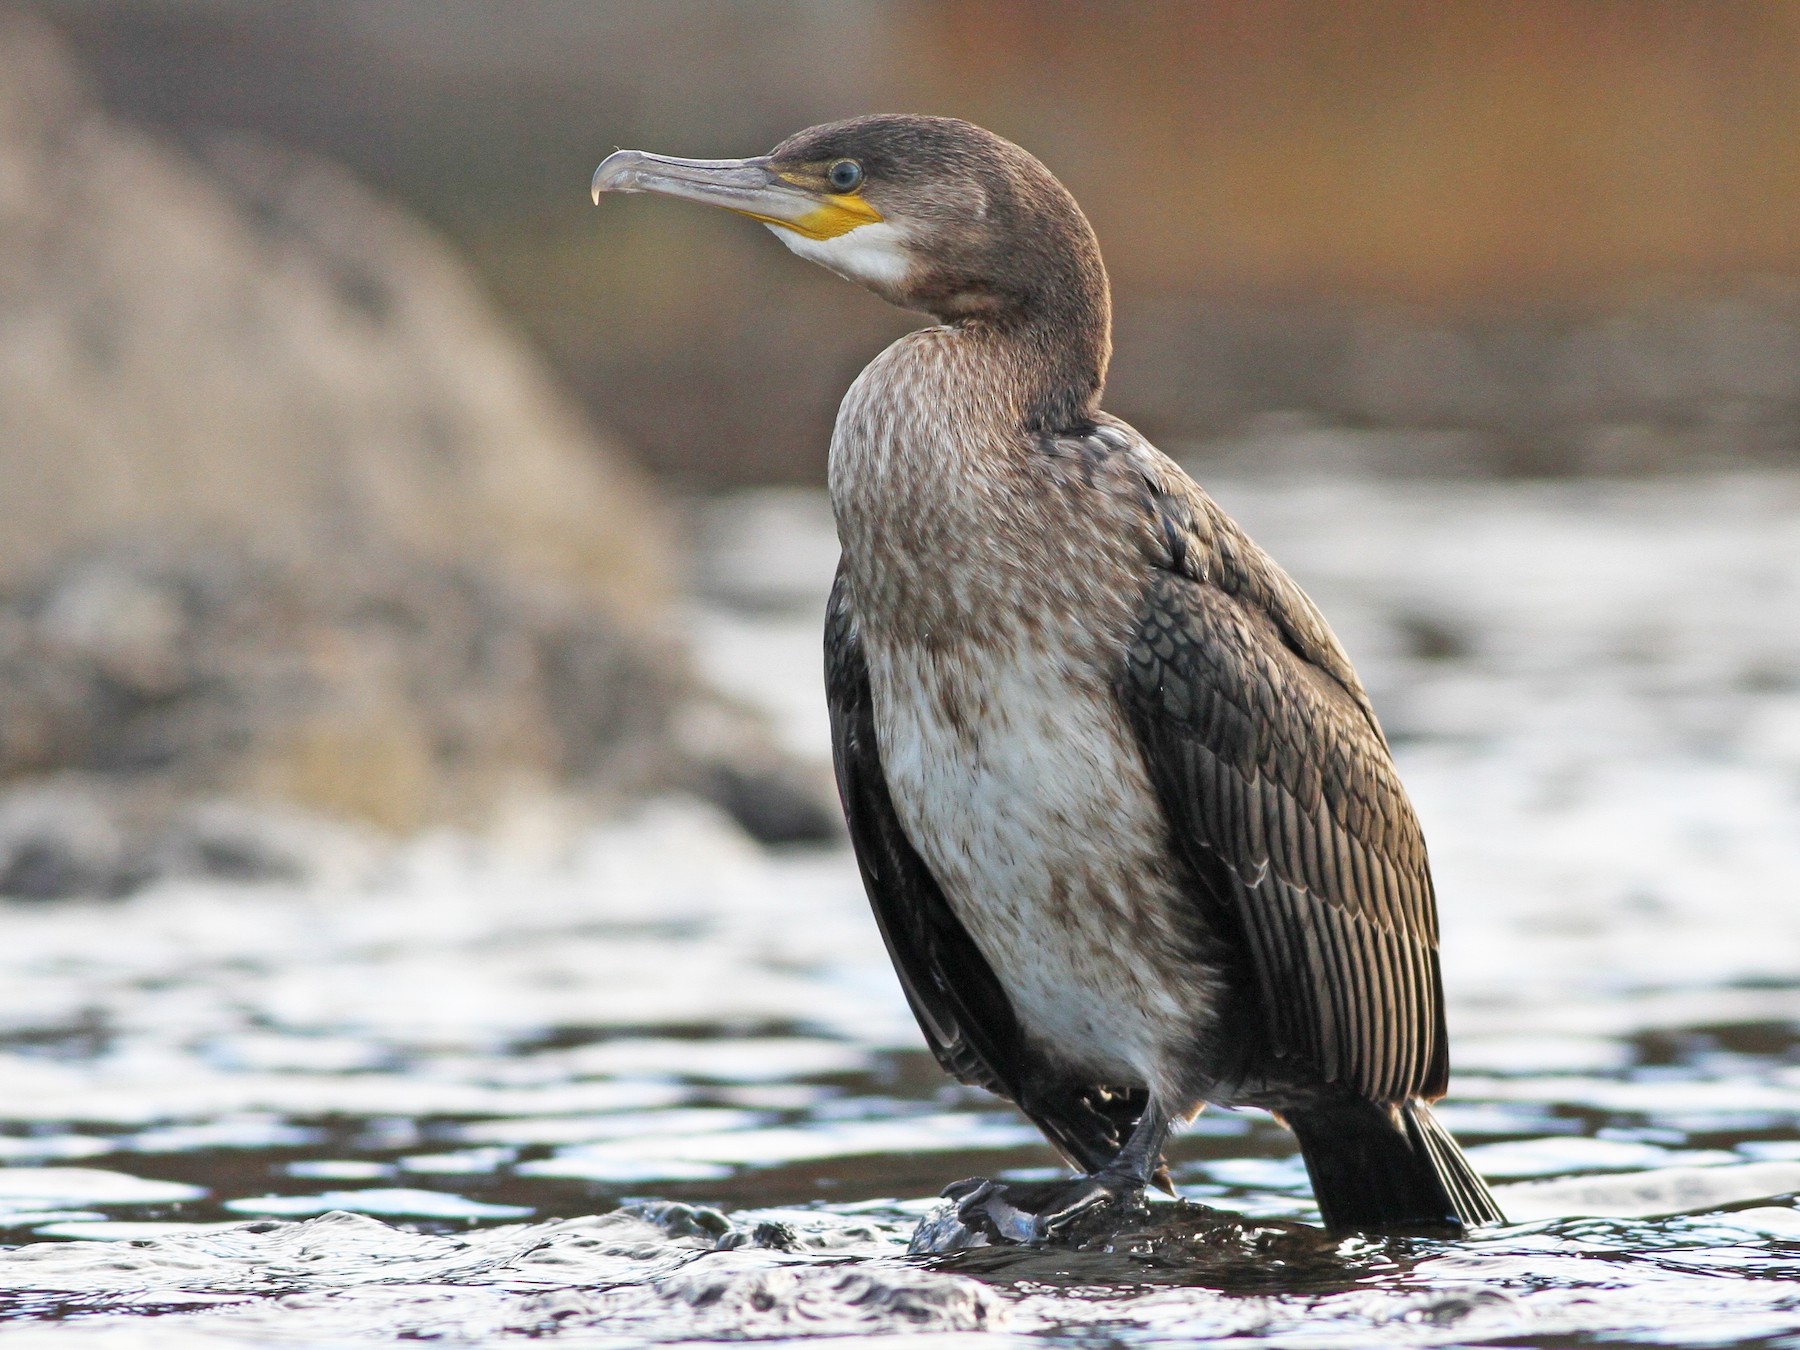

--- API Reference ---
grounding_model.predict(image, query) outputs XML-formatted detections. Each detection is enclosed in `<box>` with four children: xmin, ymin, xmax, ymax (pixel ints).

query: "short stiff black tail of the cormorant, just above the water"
<box><xmin>1282</xmin><ymin>1096</ymin><xmax>1505</xmax><ymax>1231</ymax></box>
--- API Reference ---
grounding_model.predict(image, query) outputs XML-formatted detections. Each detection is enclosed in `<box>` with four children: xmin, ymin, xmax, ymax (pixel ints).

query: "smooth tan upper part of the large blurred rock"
<box><xmin>0</xmin><ymin>5</ymin><xmax>670</xmax><ymax>614</ymax></box>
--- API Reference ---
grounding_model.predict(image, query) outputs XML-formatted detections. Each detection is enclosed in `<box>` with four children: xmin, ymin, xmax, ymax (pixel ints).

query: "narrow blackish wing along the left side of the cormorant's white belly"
<box><xmin>824</xmin><ymin>569</ymin><xmax>1145</xmax><ymax>1172</ymax></box>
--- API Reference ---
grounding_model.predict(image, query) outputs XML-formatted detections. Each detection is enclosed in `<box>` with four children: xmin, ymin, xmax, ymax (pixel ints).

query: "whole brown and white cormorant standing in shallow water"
<box><xmin>594</xmin><ymin>115</ymin><xmax>1499</xmax><ymax>1240</ymax></box>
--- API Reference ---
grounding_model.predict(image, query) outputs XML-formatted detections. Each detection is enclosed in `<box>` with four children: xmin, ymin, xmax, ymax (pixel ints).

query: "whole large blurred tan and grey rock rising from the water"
<box><xmin>0</xmin><ymin>11</ymin><xmax>835</xmax><ymax>867</ymax></box>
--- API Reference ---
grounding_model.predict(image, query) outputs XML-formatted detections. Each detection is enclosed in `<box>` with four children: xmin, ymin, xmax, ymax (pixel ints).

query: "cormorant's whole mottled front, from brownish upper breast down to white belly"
<box><xmin>832</xmin><ymin>329</ymin><xmax>1208</xmax><ymax>1107</ymax></box>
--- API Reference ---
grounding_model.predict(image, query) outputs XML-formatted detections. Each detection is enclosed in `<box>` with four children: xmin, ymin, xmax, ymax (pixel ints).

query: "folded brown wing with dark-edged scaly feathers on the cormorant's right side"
<box><xmin>1120</xmin><ymin>472</ymin><xmax>1449</xmax><ymax>1102</ymax></box>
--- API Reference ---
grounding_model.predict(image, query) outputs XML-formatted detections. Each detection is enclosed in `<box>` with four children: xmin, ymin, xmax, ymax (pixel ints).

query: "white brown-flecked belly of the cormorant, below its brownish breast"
<box><xmin>869</xmin><ymin>644</ymin><xmax>1206</xmax><ymax>1094</ymax></box>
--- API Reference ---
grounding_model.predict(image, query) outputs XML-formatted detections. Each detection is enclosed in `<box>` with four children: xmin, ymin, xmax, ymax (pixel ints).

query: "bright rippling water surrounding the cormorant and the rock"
<box><xmin>0</xmin><ymin>479</ymin><xmax>1800</xmax><ymax>1346</ymax></box>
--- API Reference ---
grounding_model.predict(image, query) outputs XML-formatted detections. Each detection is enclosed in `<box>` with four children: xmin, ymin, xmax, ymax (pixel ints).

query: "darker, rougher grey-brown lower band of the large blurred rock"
<box><xmin>0</xmin><ymin>542</ymin><xmax>687</xmax><ymax>830</ymax></box>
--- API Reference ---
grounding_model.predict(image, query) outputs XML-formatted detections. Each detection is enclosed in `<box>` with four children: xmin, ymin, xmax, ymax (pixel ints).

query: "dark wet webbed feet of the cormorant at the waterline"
<box><xmin>907</xmin><ymin>1172</ymin><xmax>1143</xmax><ymax>1255</ymax></box>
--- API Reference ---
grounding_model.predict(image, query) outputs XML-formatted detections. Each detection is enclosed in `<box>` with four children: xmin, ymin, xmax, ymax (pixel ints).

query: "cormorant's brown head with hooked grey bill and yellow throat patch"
<box><xmin>594</xmin><ymin>115</ymin><xmax>1107</xmax><ymax>333</ymax></box>
